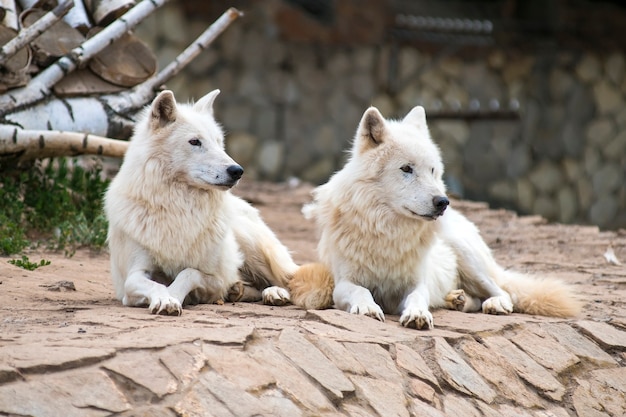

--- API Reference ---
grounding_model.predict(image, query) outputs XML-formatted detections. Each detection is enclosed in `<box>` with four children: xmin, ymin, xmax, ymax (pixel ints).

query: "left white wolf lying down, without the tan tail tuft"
<box><xmin>105</xmin><ymin>90</ymin><xmax>298</xmax><ymax>315</ymax></box>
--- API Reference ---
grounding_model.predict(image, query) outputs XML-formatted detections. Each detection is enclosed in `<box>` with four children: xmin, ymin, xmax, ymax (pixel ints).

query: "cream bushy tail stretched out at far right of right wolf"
<box><xmin>499</xmin><ymin>271</ymin><xmax>583</xmax><ymax>317</ymax></box>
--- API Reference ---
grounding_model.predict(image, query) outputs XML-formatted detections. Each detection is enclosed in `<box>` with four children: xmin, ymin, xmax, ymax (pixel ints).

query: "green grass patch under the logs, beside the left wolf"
<box><xmin>0</xmin><ymin>159</ymin><xmax>109</xmax><ymax>256</ymax></box>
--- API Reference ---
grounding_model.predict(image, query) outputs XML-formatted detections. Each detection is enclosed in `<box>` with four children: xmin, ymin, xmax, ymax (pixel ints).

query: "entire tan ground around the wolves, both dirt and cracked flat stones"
<box><xmin>0</xmin><ymin>183</ymin><xmax>626</xmax><ymax>417</ymax></box>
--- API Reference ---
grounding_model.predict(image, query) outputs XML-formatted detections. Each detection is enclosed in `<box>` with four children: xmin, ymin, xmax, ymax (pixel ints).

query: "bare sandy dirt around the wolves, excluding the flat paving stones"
<box><xmin>0</xmin><ymin>181</ymin><xmax>626</xmax><ymax>332</ymax></box>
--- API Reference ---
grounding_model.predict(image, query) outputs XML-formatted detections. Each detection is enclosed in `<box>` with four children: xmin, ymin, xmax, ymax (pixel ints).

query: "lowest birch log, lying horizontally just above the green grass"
<box><xmin>0</xmin><ymin>125</ymin><xmax>128</xmax><ymax>163</ymax></box>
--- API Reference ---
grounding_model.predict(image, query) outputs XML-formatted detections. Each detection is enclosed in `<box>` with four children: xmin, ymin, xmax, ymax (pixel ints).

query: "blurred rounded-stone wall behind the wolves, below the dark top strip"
<box><xmin>137</xmin><ymin>0</ymin><xmax>626</xmax><ymax>228</ymax></box>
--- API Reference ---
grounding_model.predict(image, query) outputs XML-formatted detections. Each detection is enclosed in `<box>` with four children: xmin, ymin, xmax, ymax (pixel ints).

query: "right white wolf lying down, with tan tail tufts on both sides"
<box><xmin>289</xmin><ymin>106</ymin><xmax>580</xmax><ymax>329</ymax></box>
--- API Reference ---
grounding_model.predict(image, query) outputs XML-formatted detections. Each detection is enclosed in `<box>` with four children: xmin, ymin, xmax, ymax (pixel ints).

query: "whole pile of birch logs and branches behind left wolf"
<box><xmin>0</xmin><ymin>0</ymin><xmax>242</xmax><ymax>167</ymax></box>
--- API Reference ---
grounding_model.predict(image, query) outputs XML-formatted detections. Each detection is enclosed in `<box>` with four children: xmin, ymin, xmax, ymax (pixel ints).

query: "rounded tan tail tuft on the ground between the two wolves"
<box><xmin>288</xmin><ymin>263</ymin><xmax>335</xmax><ymax>310</ymax></box>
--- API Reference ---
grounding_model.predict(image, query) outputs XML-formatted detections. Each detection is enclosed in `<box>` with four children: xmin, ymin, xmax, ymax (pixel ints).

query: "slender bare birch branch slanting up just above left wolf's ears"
<box><xmin>102</xmin><ymin>7</ymin><xmax>243</xmax><ymax>114</ymax></box>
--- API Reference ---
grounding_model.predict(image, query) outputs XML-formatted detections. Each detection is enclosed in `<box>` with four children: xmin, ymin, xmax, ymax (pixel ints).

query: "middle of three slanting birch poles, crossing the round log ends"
<box><xmin>0</xmin><ymin>0</ymin><xmax>167</xmax><ymax>116</ymax></box>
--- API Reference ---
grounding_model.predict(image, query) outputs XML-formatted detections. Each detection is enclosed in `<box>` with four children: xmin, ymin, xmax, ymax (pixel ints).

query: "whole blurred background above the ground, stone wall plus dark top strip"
<box><xmin>136</xmin><ymin>0</ymin><xmax>626</xmax><ymax>229</ymax></box>
